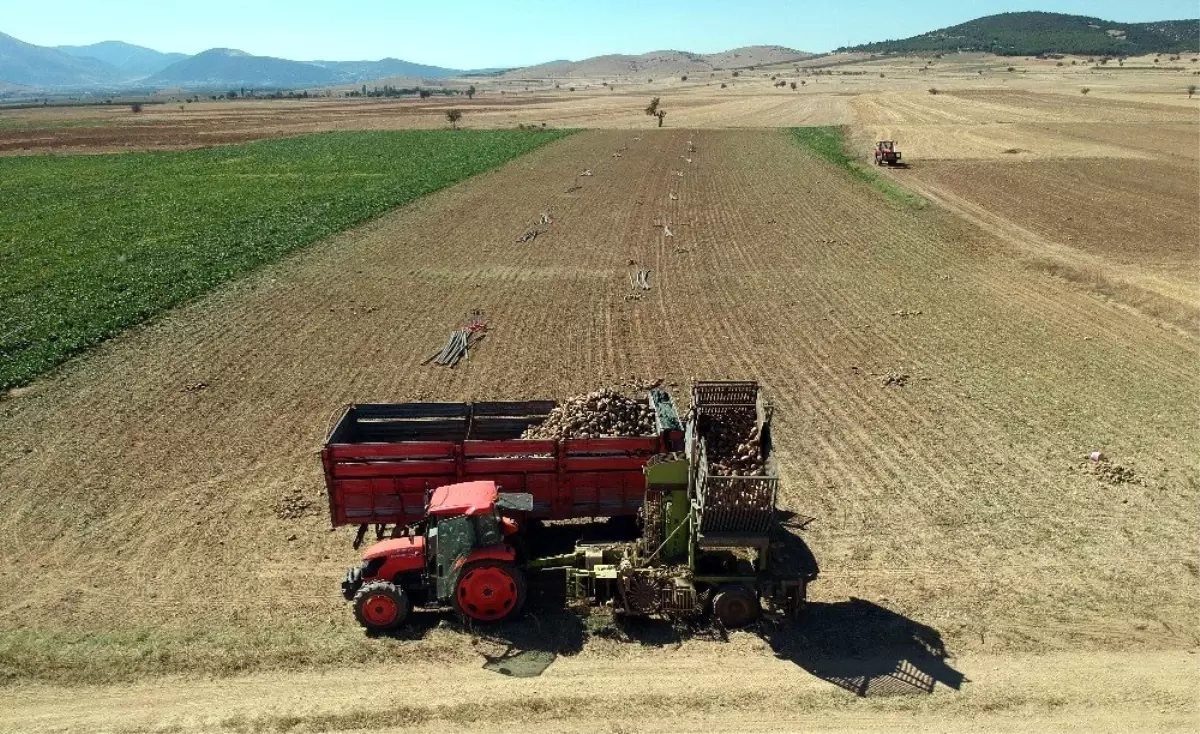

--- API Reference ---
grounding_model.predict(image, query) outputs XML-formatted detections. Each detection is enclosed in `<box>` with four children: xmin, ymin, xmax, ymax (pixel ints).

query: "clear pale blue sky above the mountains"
<box><xmin>9</xmin><ymin>0</ymin><xmax>1200</xmax><ymax>68</ymax></box>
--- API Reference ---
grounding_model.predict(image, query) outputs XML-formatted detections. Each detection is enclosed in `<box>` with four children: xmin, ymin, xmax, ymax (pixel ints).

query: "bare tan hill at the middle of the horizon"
<box><xmin>505</xmin><ymin>46</ymin><xmax>812</xmax><ymax>78</ymax></box>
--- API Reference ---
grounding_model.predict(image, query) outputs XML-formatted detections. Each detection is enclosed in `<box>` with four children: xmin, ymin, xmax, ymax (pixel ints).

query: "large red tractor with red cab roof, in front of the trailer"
<box><xmin>342</xmin><ymin>481</ymin><xmax>532</xmax><ymax>633</ymax></box>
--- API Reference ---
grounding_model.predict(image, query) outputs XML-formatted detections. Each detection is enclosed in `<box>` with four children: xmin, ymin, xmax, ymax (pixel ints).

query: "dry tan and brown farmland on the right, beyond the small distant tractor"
<box><xmin>854</xmin><ymin>83</ymin><xmax>1200</xmax><ymax>335</ymax></box>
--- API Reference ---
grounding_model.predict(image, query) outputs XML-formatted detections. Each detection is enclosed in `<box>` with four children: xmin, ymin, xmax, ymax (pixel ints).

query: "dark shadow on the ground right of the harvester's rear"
<box><xmin>760</xmin><ymin>597</ymin><xmax>967</xmax><ymax>698</ymax></box>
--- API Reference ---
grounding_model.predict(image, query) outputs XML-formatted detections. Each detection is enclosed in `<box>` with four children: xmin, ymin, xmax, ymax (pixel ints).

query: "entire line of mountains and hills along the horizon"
<box><xmin>0</xmin><ymin>12</ymin><xmax>1200</xmax><ymax>94</ymax></box>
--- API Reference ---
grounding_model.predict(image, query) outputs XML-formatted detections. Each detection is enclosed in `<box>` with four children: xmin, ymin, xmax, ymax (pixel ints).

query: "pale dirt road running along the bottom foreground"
<box><xmin>0</xmin><ymin>645</ymin><xmax>1200</xmax><ymax>734</ymax></box>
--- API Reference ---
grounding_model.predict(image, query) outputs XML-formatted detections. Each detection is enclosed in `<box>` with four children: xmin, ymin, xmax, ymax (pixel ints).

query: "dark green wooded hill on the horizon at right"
<box><xmin>839</xmin><ymin>12</ymin><xmax>1200</xmax><ymax>56</ymax></box>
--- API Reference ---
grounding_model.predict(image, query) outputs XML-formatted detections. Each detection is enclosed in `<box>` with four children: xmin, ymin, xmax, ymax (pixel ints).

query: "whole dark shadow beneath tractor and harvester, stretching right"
<box><xmin>369</xmin><ymin>525</ymin><xmax>966</xmax><ymax>697</ymax></box>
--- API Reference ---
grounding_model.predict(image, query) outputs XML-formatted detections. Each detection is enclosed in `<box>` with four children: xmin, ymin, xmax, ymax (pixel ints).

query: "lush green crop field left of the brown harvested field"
<box><xmin>0</xmin><ymin>131</ymin><xmax>569</xmax><ymax>389</ymax></box>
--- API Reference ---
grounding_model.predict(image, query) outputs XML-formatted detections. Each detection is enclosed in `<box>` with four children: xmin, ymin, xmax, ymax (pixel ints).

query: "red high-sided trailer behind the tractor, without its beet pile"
<box><xmin>322</xmin><ymin>390</ymin><xmax>683</xmax><ymax>528</ymax></box>
